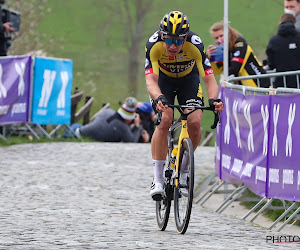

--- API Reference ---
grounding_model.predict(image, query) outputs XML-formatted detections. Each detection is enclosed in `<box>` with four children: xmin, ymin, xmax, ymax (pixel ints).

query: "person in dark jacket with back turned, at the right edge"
<box><xmin>266</xmin><ymin>14</ymin><xmax>300</xmax><ymax>88</ymax></box>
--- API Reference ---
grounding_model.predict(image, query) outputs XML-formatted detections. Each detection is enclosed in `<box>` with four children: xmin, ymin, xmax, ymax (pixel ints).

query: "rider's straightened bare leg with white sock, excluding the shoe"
<box><xmin>151</xmin><ymin>108</ymin><xmax>173</xmax><ymax>183</ymax></box>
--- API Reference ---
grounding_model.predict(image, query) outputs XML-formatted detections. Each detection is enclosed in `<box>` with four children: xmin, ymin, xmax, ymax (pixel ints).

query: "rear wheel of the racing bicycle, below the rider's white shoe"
<box><xmin>156</xmin><ymin>170</ymin><xmax>173</xmax><ymax>231</ymax></box>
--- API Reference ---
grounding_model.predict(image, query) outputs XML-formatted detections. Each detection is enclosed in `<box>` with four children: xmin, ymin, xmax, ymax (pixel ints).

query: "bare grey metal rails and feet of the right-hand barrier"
<box><xmin>195</xmin><ymin>70</ymin><xmax>300</xmax><ymax>231</ymax></box>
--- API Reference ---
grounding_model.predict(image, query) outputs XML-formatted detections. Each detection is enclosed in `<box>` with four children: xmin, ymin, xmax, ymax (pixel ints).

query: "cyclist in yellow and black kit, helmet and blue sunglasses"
<box><xmin>145</xmin><ymin>11</ymin><xmax>223</xmax><ymax>200</ymax></box>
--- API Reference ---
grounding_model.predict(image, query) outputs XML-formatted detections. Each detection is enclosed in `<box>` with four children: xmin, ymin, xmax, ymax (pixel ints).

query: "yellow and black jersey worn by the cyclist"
<box><xmin>145</xmin><ymin>31</ymin><xmax>213</xmax><ymax>78</ymax></box>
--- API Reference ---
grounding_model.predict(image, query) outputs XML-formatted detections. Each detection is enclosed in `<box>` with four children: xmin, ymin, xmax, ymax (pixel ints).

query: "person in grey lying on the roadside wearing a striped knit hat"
<box><xmin>75</xmin><ymin>97</ymin><xmax>147</xmax><ymax>142</ymax></box>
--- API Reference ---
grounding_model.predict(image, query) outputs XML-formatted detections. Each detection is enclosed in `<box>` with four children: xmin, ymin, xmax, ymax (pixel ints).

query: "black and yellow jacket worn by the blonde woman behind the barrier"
<box><xmin>211</xmin><ymin>36</ymin><xmax>270</xmax><ymax>87</ymax></box>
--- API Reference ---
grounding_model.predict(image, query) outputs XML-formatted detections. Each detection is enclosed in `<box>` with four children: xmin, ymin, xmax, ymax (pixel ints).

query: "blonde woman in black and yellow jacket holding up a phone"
<box><xmin>207</xmin><ymin>22</ymin><xmax>270</xmax><ymax>87</ymax></box>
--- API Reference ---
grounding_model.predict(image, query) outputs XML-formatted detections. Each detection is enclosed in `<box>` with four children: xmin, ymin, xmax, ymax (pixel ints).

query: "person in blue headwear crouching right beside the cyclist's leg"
<box><xmin>136</xmin><ymin>102</ymin><xmax>155</xmax><ymax>142</ymax></box>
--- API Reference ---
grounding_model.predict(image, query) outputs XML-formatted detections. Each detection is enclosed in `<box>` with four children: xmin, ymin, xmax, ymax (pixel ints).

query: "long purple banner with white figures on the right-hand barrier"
<box><xmin>216</xmin><ymin>88</ymin><xmax>300</xmax><ymax>201</ymax></box>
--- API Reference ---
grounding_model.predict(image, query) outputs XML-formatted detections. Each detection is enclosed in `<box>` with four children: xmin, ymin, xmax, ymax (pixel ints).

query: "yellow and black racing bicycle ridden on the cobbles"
<box><xmin>156</xmin><ymin>99</ymin><xmax>219</xmax><ymax>234</ymax></box>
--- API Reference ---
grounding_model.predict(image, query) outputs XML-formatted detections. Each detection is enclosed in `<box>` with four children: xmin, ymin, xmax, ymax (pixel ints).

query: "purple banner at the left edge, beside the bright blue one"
<box><xmin>0</xmin><ymin>56</ymin><xmax>31</xmax><ymax>124</ymax></box>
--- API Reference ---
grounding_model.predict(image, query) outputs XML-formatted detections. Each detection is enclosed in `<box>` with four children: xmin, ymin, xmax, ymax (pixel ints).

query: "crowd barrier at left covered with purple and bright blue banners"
<box><xmin>0</xmin><ymin>56</ymin><xmax>73</xmax><ymax>138</ymax></box>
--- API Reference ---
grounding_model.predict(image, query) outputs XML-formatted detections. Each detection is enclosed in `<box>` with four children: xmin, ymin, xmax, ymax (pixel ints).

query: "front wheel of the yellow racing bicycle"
<box><xmin>174</xmin><ymin>138</ymin><xmax>194</xmax><ymax>234</ymax></box>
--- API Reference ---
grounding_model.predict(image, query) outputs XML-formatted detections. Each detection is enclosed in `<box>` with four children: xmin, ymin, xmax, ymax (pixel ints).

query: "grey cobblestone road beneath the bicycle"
<box><xmin>0</xmin><ymin>143</ymin><xmax>299</xmax><ymax>249</ymax></box>
